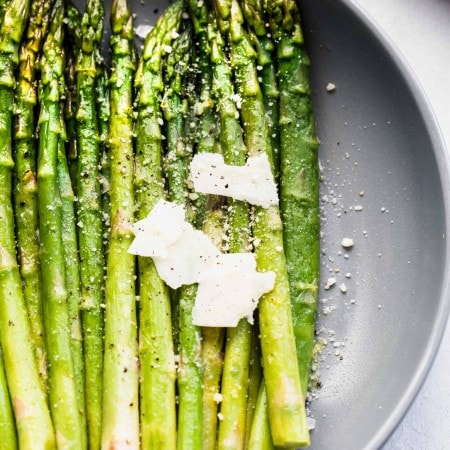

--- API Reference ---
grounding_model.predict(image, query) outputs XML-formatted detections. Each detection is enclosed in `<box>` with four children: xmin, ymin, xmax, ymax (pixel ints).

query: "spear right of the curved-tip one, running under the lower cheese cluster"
<box><xmin>162</xmin><ymin>28</ymin><xmax>203</xmax><ymax>449</ymax></box>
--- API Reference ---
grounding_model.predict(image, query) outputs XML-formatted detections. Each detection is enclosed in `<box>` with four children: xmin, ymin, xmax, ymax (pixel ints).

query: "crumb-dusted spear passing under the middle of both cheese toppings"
<box><xmin>205</xmin><ymin>14</ymin><xmax>251</xmax><ymax>448</ymax></box>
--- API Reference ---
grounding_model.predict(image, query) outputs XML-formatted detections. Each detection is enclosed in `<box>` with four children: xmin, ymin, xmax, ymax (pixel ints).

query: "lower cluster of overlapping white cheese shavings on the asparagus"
<box><xmin>128</xmin><ymin>200</ymin><xmax>275</xmax><ymax>327</ymax></box>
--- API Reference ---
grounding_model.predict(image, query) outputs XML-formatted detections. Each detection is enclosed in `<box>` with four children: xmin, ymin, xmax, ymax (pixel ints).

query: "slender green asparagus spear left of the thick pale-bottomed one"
<box><xmin>76</xmin><ymin>0</ymin><xmax>105</xmax><ymax>449</ymax></box>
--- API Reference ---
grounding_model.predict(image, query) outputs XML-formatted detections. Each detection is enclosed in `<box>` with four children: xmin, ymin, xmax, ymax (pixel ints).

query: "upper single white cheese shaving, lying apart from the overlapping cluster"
<box><xmin>190</xmin><ymin>153</ymin><xmax>278</xmax><ymax>208</ymax></box>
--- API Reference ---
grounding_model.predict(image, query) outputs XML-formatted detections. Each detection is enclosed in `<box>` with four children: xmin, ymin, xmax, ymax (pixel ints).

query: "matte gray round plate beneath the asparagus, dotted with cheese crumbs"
<box><xmin>101</xmin><ymin>0</ymin><xmax>450</xmax><ymax>450</ymax></box>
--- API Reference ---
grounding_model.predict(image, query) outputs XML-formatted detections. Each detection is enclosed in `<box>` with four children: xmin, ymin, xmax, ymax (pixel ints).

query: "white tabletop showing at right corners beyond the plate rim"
<box><xmin>353</xmin><ymin>0</ymin><xmax>450</xmax><ymax>450</ymax></box>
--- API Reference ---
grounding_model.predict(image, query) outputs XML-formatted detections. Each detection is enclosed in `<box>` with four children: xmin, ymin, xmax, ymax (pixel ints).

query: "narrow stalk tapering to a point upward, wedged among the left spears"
<box><xmin>57</xmin><ymin>136</ymin><xmax>87</xmax><ymax>447</ymax></box>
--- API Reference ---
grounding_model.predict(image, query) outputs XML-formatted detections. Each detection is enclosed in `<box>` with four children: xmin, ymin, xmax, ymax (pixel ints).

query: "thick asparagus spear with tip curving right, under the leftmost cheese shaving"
<box><xmin>135</xmin><ymin>1</ymin><xmax>183</xmax><ymax>449</ymax></box>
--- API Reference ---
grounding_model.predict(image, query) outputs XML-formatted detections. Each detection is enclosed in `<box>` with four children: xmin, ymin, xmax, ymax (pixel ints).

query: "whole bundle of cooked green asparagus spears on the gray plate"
<box><xmin>0</xmin><ymin>0</ymin><xmax>319</xmax><ymax>449</ymax></box>
